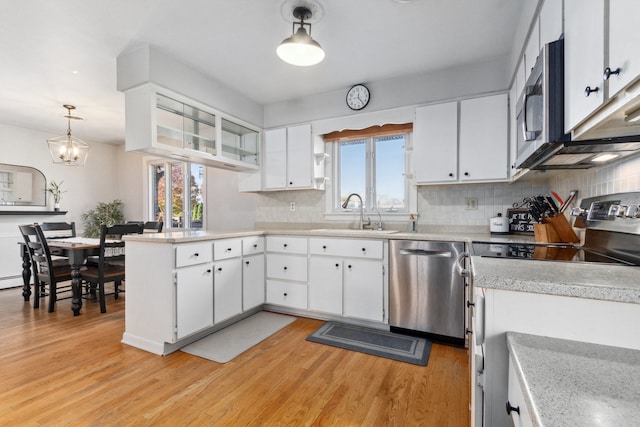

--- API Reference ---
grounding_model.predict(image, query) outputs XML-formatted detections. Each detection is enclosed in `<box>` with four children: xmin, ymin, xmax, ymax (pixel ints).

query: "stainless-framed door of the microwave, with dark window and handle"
<box><xmin>516</xmin><ymin>55</ymin><xmax>545</xmax><ymax>167</ymax></box>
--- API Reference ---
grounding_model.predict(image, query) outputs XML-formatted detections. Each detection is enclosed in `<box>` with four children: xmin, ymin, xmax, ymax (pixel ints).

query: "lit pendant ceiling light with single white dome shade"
<box><xmin>276</xmin><ymin>6</ymin><xmax>324</xmax><ymax>67</ymax></box>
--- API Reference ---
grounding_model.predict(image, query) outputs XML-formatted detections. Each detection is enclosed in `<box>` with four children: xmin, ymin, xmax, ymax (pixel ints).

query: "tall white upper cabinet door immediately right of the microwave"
<box><xmin>564</xmin><ymin>0</ymin><xmax>604</xmax><ymax>132</ymax></box>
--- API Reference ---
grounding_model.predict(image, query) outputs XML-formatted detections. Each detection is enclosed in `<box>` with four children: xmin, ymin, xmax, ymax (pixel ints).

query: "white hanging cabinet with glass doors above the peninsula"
<box><xmin>125</xmin><ymin>84</ymin><xmax>261</xmax><ymax>170</ymax></box>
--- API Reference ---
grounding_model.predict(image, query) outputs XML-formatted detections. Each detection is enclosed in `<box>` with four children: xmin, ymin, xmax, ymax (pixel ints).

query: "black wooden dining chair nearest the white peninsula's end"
<box><xmin>80</xmin><ymin>223</ymin><xmax>143</xmax><ymax>313</ymax></box>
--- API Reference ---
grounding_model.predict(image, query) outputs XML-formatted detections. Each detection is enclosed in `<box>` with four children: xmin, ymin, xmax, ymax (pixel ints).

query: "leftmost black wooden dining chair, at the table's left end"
<box><xmin>18</xmin><ymin>224</ymin><xmax>71</xmax><ymax>313</ymax></box>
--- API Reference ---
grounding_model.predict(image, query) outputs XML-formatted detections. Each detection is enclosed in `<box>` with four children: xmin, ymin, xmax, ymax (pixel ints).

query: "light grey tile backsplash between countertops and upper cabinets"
<box><xmin>256</xmin><ymin>156</ymin><xmax>640</xmax><ymax>231</ymax></box>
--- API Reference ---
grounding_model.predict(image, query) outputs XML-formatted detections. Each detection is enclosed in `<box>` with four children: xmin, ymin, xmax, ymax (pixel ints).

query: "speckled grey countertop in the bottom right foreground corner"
<box><xmin>507</xmin><ymin>332</ymin><xmax>640</xmax><ymax>427</ymax></box>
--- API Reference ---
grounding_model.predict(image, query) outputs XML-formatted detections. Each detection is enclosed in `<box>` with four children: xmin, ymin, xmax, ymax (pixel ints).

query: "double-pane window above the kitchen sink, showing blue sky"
<box><xmin>333</xmin><ymin>133</ymin><xmax>409</xmax><ymax>213</ymax></box>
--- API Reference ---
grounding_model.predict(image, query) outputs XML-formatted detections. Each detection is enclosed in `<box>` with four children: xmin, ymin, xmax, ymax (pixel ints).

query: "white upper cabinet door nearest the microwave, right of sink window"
<box><xmin>459</xmin><ymin>94</ymin><xmax>509</xmax><ymax>181</ymax></box>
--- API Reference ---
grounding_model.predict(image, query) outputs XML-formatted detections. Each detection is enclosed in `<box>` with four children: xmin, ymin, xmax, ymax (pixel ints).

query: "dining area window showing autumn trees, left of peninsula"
<box><xmin>149</xmin><ymin>162</ymin><xmax>205</xmax><ymax>229</ymax></box>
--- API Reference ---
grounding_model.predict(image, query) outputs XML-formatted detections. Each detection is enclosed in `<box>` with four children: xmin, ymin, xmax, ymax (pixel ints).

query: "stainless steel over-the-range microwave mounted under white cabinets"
<box><xmin>516</xmin><ymin>39</ymin><xmax>570</xmax><ymax>168</ymax></box>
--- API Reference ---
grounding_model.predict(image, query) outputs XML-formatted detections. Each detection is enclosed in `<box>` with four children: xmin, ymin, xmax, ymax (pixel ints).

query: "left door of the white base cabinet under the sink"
<box><xmin>309</xmin><ymin>256</ymin><xmax>342</xmax><ymax>315</ymax></box>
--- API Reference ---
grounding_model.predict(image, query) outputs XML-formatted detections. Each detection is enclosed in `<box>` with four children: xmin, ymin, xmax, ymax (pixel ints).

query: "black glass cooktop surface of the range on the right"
<box><xmin>472</xmin><ymin>242</ymin><xmax>634</xmax><ymax>265</ymax></box>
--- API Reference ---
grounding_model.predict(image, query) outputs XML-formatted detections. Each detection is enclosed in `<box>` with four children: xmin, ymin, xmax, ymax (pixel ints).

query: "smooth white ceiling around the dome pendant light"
<box><xmin>0</xmin><ymin>0</ymin><xmax>525</xmax><ymax>144</ymax></box>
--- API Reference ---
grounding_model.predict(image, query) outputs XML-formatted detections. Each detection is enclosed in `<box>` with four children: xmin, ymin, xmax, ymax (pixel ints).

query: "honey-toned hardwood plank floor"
<box><xmin>0</xmin><ymin>289</ymin><xmax>469</xmax><ymax>426</ymax></box>
